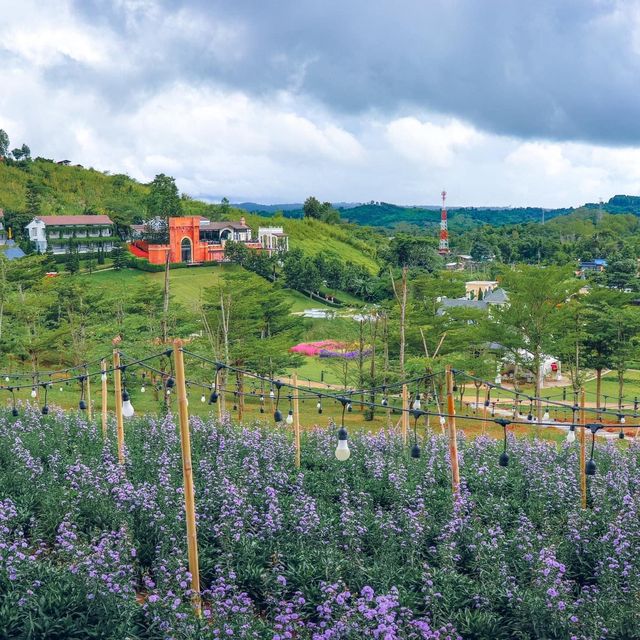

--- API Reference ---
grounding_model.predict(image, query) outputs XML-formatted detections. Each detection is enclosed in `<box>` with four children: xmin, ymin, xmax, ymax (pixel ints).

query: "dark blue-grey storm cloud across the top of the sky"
<box><xmin>63</xmin><ymin>0</ymin><xmax>640</xmax><ymax>145</ymax></box>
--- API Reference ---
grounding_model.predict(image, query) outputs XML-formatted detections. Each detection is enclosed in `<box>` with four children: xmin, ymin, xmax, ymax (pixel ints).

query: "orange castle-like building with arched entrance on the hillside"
<box><xmin>133</xmin><ymin>216</ymin><xmax>288</xmax><ymax>264</ymax></box>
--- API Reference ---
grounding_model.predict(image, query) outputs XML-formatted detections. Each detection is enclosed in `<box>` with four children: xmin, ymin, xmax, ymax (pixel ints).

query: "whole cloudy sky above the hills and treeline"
<box><xmin>0</xmin><ymin>0</ymin><xmax>640</xmax><ymax>207</ymax></box>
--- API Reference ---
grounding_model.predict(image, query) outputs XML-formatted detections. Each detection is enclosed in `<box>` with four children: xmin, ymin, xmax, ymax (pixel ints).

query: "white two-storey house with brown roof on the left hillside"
<box><xmin>25</xmin><ymin>215</ymin><xmax>114</xmax><ymax>254</ymax></box>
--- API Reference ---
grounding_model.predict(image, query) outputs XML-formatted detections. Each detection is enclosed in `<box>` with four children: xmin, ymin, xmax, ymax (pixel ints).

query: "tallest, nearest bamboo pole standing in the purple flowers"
<box><xmin>173</xmin><ymin>340</ymin><xmax>202</xmax><ymax>617</ymax></box>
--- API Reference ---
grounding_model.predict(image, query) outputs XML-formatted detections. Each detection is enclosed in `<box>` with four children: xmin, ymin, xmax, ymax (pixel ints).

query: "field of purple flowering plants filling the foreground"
<box><xmin>0</xmin><ymin>407</ymin><xmax>640</xmax><ymax>640</ymax></box>
